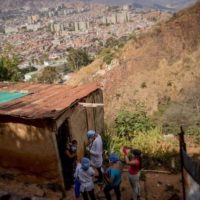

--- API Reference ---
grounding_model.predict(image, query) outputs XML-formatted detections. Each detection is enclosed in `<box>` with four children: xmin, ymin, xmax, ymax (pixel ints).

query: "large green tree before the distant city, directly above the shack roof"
<box><xmin>67</xmin><ymin>48</ymin><xmax>92</xmax><ymax>71</ymax></box>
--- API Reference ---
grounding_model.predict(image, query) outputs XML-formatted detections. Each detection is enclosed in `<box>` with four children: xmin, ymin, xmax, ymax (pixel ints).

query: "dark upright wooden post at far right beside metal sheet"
<box><xmin>179</xmin><ymin>126</ymin><xmax>186</xmax><ymax>200</ymax></box>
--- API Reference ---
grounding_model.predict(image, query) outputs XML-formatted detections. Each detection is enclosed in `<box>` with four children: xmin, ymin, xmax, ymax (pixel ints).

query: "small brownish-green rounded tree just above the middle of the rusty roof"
<box><xmin>37</xmin><ymin>67</ymin><xmax>61</xmax><ymax>83</ymax></box>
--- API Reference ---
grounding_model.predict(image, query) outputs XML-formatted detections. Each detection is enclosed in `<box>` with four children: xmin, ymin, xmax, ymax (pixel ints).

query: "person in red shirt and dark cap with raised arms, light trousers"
<box><xmin>123</xmin><ymin>148</ymin><xmax>141</xmax><ymax>200</ymax></box>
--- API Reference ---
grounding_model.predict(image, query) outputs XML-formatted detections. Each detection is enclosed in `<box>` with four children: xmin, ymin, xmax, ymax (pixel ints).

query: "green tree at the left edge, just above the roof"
<box><xmin>0</xmin><ymin>55</ymin><xmax>22</xmax><ymax>81</ymax></box>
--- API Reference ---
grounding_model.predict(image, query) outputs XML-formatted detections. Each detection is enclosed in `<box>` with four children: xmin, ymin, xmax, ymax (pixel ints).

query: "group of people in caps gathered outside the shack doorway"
<box><xmin>66</xmin><ymin>130</ymin><xmax>141</xmax><ymax>200</ymax></box>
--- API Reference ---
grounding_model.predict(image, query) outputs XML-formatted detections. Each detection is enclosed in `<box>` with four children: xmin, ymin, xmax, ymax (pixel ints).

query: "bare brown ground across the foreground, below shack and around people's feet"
<box><xmin>0</xmin><ymin>171</ymin><xmax>181</xmax><ymax>200</ymax></box>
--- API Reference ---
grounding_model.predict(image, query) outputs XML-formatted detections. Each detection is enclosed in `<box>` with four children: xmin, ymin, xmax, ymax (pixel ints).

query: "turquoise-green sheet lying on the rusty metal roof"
<box><xmin>0</xmin><ymin>91</ymin><xmax>28</xmax><ymax>103</ymax></box>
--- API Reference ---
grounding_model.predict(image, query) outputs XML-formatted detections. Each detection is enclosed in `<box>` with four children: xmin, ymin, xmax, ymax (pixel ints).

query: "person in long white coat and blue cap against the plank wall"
<box><xmin>87</xmin><ymin>130</ymin><xmax>103</xmax><ymax>182</ymax></box>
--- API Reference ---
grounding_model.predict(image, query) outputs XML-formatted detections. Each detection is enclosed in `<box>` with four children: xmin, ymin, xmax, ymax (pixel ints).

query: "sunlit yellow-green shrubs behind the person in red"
<box><xmin>105</xmin><ymin>128</ymin><xmax>178</xmax><ymax>168</ymax></box>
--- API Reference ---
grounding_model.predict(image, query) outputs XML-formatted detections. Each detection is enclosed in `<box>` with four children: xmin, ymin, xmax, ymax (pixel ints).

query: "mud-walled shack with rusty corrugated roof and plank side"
<box><xmin>0</xmin><ymin>82</ymin><xmax>104</xmax><ymax>189</ymax></box>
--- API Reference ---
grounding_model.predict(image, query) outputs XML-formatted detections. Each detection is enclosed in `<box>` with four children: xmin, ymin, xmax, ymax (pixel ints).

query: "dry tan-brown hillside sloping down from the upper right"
<box><xmin>67</xmin><ymin>3</ymin><xmax>200</xmax><ymax>133</ymax></box>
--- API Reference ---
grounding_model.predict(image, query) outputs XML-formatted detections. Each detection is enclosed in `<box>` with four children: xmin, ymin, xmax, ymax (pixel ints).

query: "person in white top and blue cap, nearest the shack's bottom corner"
<box><xmin>75</xmin><ymin>157</ymin><xmax>96</xmax><ymax>200</ymax></box>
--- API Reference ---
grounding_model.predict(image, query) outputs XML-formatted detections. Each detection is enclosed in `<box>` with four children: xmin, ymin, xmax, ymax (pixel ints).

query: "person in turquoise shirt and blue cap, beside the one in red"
<box><xmin>104</xmin><ymin>153</ymin><xmax>122</xmax><ymax>200</ymax></box>
